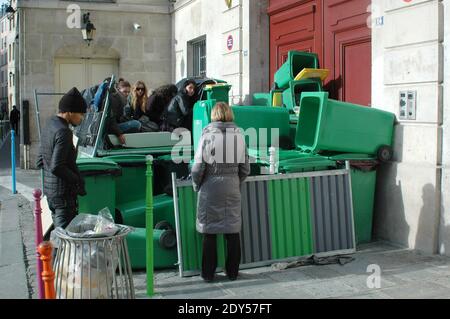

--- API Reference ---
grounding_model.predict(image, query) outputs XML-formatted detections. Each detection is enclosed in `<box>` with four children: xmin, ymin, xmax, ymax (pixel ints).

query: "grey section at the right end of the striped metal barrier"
<box><xmin>310</xmin><ymin>175</ymin><xmax>355</xmax><ymax>253</ymax></box>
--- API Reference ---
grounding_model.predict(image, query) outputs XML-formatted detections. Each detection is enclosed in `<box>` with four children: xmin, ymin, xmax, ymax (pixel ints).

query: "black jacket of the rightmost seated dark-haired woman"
<box><xmin>164</xmin><ymin>92</ymin><xmax>195</xmax><ymax>130</ymax></box>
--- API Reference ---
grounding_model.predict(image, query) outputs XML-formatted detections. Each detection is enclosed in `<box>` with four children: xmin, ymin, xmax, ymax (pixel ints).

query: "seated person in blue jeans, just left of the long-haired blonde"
<box><xmin>108</xmin><ymin>81</ymin><xmax>141</xmax><ymax>144</ymax></box>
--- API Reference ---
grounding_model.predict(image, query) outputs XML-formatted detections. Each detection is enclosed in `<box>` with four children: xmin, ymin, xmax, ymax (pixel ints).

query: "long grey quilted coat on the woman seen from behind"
<box><xmin>191</xmin><ymin>122</ymin><xmax>250</xmax><ymax>234</ymax></box>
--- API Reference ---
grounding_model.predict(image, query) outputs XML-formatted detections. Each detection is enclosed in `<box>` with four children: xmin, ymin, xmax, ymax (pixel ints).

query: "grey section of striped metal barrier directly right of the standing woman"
<box><xmin>241</xmin><ymin>181</ymin><xmax>272</xmax><ymax>264</ymax></box>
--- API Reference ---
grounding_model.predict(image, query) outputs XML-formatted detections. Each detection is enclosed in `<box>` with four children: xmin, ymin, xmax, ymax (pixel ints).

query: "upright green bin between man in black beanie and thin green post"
<box><xmin>77</xmin><ymin>158</ymin><xmax>121</xmax><ymax>217</ymax></box>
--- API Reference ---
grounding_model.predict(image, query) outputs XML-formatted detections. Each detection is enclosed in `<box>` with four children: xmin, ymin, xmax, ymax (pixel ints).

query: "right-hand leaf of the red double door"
<box><xmin>324</xmin><ymin>0</ymin><xmax>372</xmax><ymax>105</ymax></box>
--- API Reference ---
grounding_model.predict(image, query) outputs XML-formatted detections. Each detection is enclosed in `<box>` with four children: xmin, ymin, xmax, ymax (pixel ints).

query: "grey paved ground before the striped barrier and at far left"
<box><xmin>0</xmin><ymin>170</ymin><xmax>450</xmax><ymax>299</ymax></box>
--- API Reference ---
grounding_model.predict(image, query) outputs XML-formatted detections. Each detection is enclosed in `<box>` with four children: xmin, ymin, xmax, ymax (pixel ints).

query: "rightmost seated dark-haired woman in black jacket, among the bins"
<box><xmin>162</xmin><ymin>80</ymin><xmax>196</xmax><ymax>132</ymax></box>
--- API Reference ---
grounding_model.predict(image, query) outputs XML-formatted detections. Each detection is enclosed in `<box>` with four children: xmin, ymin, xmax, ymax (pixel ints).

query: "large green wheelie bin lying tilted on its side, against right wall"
<box><xmin>295</xmin><ymin>92</ymin><xmax>395</xmax><ymax>161</ymax></box>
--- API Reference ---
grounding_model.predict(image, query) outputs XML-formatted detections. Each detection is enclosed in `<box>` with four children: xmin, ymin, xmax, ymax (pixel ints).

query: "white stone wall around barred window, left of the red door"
<box><xmin>172</xmin><ymin>0</ymin><xmax>269</xmax><ymax>104</ymax></box>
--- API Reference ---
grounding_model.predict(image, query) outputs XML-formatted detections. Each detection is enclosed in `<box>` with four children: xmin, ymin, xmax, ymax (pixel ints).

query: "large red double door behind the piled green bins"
<box><xmin>268</xmin><ymin>0</ymin><xmax>372</xmax><ymax>105</ymax></box>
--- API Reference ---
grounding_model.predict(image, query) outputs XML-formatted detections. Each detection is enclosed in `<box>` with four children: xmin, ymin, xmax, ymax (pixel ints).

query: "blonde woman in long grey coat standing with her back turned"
<box><xmin>191</xmin><ymin>102</ymin><xmax>250</xmax><ymax>282</ymax></box>
